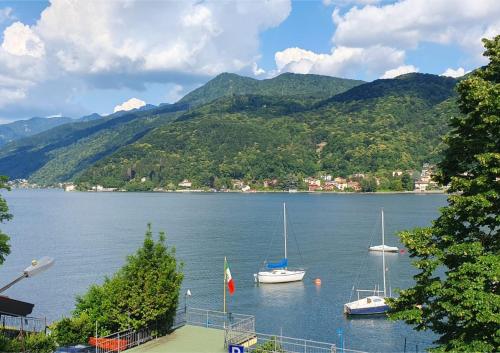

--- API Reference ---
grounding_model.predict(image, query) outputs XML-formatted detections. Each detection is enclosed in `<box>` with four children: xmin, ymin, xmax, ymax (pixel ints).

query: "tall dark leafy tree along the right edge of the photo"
<box><xmin>389</xmin><ymin>36</ymin><xmax>500</xmax><ymax>352</ymax></box>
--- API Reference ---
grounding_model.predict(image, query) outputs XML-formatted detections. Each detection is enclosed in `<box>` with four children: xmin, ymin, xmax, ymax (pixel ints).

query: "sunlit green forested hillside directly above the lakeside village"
<box><xmin>78</xmin><ymin>74</ymin><xmax>458</xmax><ymax>189</ymax></box>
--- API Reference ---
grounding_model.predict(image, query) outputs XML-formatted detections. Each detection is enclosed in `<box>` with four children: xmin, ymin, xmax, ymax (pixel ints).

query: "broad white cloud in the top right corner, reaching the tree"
<box><xmin>332</xmin><ymin>0</ymin><xmax>500</xmax><ymax>62</ymax></box>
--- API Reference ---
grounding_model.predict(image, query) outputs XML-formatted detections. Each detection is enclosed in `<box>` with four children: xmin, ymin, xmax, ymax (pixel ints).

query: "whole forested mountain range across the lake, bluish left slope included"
<box><xmin>0</xmin><ymin>74</ymin><xmax>459</xmax><ymax>190</ymax></box>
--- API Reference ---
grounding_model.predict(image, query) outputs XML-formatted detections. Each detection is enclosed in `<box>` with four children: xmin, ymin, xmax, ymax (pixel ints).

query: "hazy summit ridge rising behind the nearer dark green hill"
<box><xmin>179</xmin><ymin>73</ymin><xmax>364</xmax><ymax>106</ymax></box>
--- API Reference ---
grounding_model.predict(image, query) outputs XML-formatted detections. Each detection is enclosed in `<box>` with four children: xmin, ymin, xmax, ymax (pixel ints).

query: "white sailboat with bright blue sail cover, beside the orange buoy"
<box><xmin>254</xmin><ymin>203</ymin><xmax>306</xmax><ymax>283</ymax></box>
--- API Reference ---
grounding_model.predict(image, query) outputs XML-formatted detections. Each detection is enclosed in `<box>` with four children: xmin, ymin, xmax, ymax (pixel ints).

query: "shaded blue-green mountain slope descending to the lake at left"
<box><xmin>0</xmin><ymin>105</ymin><xmax>185</xmax><ymax>184</ymax></box>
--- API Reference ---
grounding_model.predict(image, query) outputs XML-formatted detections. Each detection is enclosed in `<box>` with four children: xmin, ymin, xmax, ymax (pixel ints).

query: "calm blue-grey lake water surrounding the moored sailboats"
<box><xmin>0</xmin><ymin>190</ymin><xmax>446</xmax><ymax>352</ymax></box>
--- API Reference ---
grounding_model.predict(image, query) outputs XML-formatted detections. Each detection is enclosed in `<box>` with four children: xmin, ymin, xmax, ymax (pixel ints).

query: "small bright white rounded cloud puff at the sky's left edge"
<box><xmin>2</xmin><ymin>22</ymin><xmax>45</xmax><ymax>58</ymax></box>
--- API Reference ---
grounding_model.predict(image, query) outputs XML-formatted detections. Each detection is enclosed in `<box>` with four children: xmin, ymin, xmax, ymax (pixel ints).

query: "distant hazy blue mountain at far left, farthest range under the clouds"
<box><xmin>0</xmin><ymin>117</ymin><xmax>72</xmax><ymax>146</ymax></box>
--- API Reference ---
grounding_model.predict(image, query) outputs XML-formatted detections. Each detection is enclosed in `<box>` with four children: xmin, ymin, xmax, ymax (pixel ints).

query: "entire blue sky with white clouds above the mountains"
<box><xmin>0</xmin><ymin>0</ymin><xmax>500</xmax><ymax>123</ymax></box>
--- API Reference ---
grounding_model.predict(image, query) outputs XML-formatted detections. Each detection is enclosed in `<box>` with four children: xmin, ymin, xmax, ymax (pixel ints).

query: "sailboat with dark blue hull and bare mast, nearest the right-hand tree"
<box><xmin>344</xmin><ymin>209</ymin><xmax>389</xmax><ymax>315</ymax></box>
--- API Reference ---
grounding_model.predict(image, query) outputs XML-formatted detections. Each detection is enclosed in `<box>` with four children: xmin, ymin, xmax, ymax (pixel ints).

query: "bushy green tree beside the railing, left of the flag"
<box><xmin>54</xmin><ymin>225</ymin><xmax>183</xmax><ymax>344</ymax></box>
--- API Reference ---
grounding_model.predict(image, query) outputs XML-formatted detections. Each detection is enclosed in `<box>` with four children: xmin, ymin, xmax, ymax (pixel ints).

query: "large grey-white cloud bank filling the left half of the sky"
<box><xmin>0</xmin><ymin>0</ymin><xmax>291</xmax><ymax>116</ymax></box>
